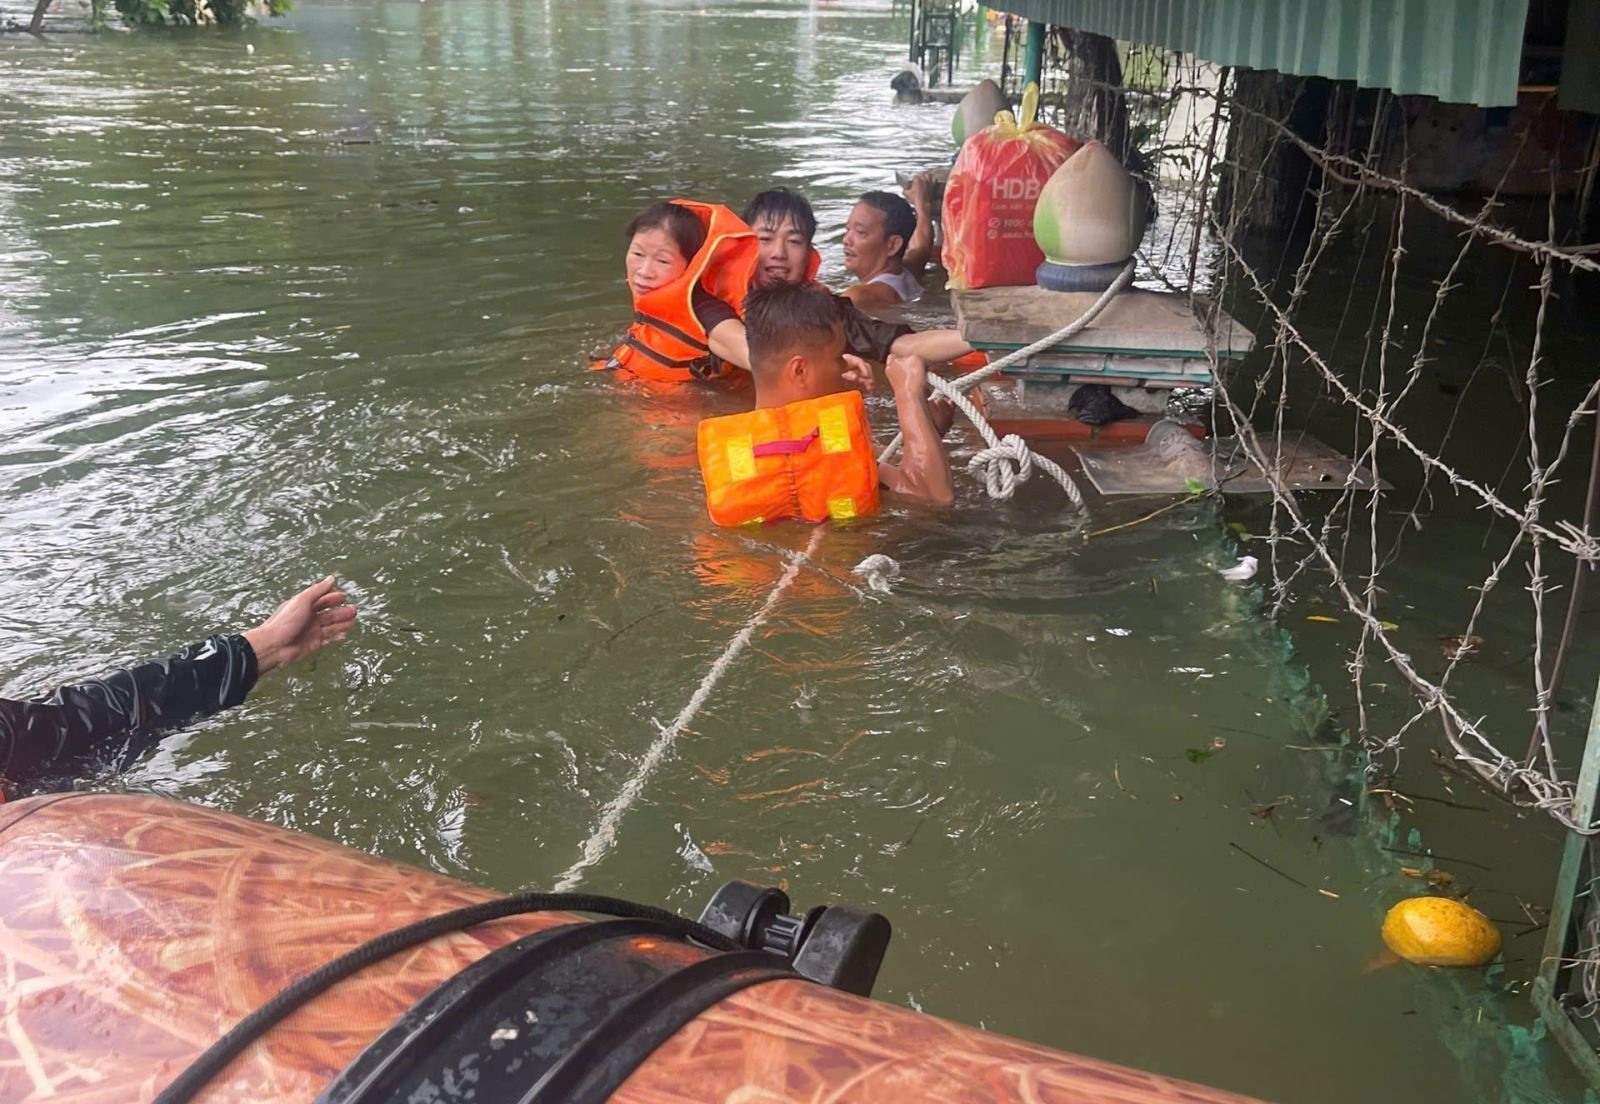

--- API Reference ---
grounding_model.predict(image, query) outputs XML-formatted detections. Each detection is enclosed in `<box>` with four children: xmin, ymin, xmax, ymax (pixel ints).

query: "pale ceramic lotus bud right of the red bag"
<box><xmin>1034</xmin><ymin>142</ymin><xmax>1149</xmax><ymax>264</ymax></box>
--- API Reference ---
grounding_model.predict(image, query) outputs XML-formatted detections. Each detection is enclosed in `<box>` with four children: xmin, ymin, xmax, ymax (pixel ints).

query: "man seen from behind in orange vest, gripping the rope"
<box><xmin>699</xmin><ymin>282</ymin><xmax>955</xmax><ymax>525</ymax></box>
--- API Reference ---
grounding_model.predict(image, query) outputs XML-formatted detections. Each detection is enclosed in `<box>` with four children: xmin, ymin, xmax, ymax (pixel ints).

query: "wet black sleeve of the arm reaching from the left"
<box><xmin>0</xmin><ymin>635</ymin><xmax>256</xmax><ymax>789</ymax></box>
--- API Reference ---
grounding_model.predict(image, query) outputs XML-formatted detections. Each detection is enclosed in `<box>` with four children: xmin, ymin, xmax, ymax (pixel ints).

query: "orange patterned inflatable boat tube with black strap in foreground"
<box><xmin>0</xmin><ymin>794</ymin><xmax>1273</xmax><ymax>1104</ymax></box>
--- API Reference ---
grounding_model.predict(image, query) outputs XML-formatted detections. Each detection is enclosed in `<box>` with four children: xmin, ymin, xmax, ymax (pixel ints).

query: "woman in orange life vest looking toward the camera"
<box><xmin>608</xmin><ymin>200</ymin><xmax>757</xmax><ymax>382</ymax></box>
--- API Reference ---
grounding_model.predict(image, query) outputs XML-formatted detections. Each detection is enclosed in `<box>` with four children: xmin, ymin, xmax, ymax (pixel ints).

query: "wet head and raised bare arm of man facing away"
<box><xmin>744</xmin><ymin>282</ymin><xmax>955</xmax><ymax>506</ymax></box>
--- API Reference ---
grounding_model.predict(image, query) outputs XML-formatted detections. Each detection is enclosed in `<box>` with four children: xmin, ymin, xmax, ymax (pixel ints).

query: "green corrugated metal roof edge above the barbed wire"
<box><xmin>986</xmin><ymin>0</ymin><xmax>1528</xmax><ymax>107</ymax></box>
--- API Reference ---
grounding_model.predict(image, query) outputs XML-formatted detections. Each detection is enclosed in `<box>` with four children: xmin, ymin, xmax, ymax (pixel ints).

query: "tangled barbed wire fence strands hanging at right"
<box><xmin>1024</xmin><ymin>43</ymin><xmax>1600</xmax><ymax>834</ymax></box>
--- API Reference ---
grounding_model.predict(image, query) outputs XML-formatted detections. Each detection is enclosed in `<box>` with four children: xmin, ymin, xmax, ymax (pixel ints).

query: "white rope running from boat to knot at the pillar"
<box><xmin>554</xmin><ymin>261</ymin><xmax>1133</xmax><ymax>893</ymax></box>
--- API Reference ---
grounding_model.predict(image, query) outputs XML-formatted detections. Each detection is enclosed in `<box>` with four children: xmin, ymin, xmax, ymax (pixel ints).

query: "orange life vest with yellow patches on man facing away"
<box><xmin>699</xmin><ymin>390</ymin><xmax>878</xmax><ymax>525</ymax></box>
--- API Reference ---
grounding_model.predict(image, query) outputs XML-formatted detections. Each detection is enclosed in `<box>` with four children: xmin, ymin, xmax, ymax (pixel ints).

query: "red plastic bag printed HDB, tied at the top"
<box><xmin>944</xmin><ymin>85</ymin><xmax>1078</xmax><ymax>288</ymax></box>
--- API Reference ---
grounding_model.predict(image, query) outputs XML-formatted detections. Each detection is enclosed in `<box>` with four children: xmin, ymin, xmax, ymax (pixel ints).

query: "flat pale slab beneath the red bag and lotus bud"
<box><xmin>950</xmin><ymin>286</ymin><xmax>1256</xmax><ymax>387</ymax></box>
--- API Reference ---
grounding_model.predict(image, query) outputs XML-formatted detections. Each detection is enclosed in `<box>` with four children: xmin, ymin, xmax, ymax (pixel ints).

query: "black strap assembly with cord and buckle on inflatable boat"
<box><xmin>154</xmin><ymin>882</ymin><xmax>890</xmax><ymax>1104</ymax></box>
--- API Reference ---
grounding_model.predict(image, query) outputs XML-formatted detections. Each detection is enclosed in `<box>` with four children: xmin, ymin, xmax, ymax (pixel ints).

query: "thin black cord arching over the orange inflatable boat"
<box><xmin>152</xmin><ymin>893</ymin><xmax>739</xmax><ymax>1104</ymax></box>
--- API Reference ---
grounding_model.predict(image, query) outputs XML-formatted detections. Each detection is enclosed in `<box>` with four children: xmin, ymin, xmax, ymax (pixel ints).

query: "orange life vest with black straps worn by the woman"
<box><xmin>605</xmin><ymin>200</ymin><xmax>758</xmax><ymax>382</ymax></box>
